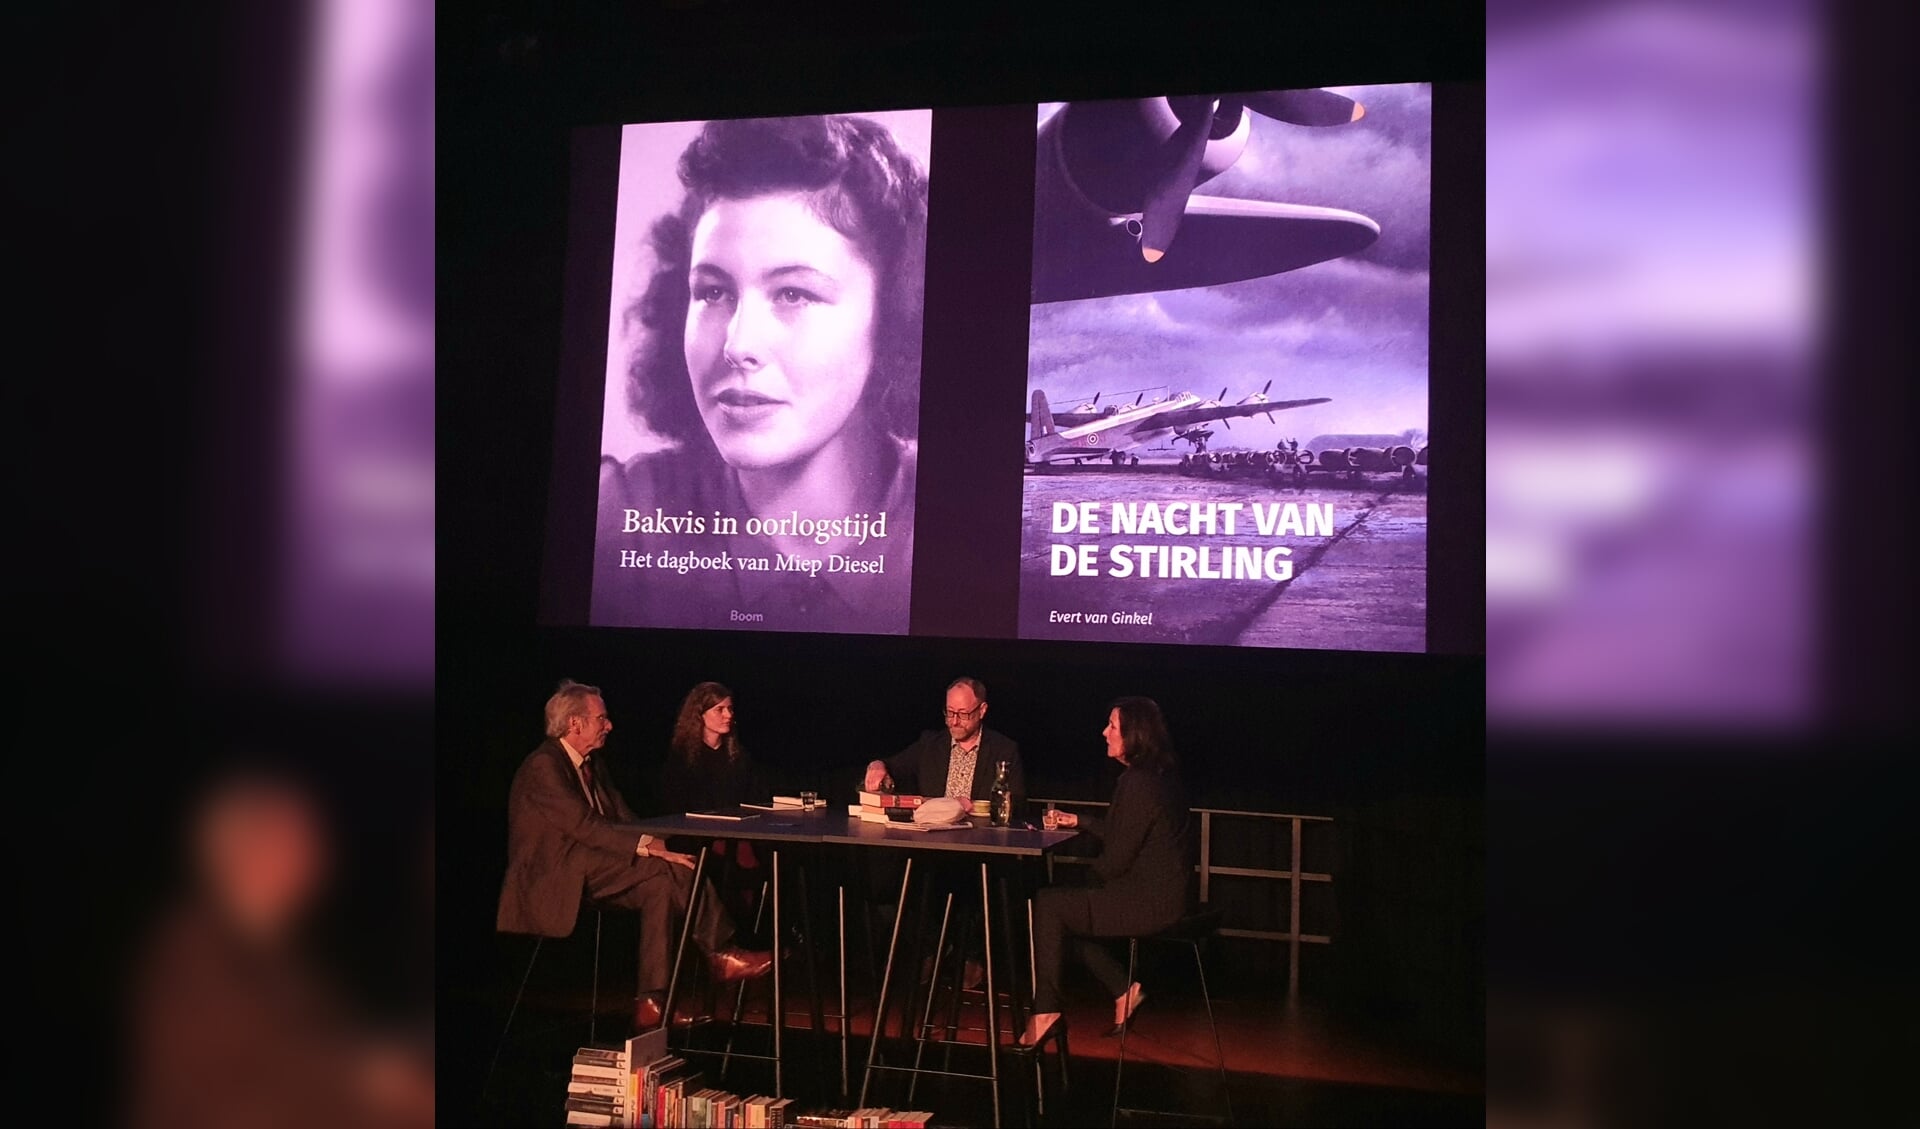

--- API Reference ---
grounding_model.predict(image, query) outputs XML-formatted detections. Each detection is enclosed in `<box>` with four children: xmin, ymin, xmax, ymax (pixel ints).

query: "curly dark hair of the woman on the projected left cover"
<box><xmin>626</xmin><ymin>117</ymin><xmax>927</xmax><ymax>451</ymax></box>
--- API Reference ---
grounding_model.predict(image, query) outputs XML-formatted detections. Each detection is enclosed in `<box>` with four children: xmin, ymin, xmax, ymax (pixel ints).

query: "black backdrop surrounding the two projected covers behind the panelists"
<box><xmin>436</xmin><ymin>2</ymin><xmax>1484</xmax><ymax>1056</ymax></box>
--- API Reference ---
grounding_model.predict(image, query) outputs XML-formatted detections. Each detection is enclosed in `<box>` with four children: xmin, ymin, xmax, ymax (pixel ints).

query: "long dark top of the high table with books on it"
<box><xmin>622</xmin><ymin>808</ymin><xmax>1079</xmax><ymax>856</ymax></box>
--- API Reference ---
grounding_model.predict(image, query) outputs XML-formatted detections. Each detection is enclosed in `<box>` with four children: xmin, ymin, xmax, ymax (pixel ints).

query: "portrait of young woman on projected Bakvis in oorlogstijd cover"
<box><xmin>591</xmin><ymin>117</ymin><xmax>927</xmax><ymax>634</ymax></box>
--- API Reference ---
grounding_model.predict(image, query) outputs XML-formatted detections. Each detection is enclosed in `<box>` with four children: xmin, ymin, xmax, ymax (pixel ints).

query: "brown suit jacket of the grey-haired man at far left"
<box><xmin>493</xmin><ymin>737</ymin><xmax>639</xmax><ymax>937</ymax></box>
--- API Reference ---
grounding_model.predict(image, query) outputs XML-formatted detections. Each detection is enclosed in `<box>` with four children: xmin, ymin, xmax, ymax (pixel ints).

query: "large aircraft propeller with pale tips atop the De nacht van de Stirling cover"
<box><xmin>1140</xmin><ymin>90</ymin><xmax>1367</xmax><ymax>263</ymax></box>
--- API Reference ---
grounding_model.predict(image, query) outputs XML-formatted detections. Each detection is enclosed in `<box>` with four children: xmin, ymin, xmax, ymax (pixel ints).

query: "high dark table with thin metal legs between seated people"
<box><xmin>628</xmin><ymin>808</ymin><xmax>1079</xmax><ymax>1125</ymax></box>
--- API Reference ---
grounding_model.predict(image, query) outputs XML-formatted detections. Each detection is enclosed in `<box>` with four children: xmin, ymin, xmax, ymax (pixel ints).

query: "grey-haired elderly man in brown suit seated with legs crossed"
<box><xmin>495</xmin><ymin>680</ymin><xmax>772</xmax><ymax>1031</ymax></box>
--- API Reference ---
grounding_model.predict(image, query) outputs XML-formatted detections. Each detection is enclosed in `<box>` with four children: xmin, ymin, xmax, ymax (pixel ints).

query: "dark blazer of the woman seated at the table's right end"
<box><xmin>1081</xmin><ymin>768</ymin><xmax>1194</xmax><ymax>937</ymax></box>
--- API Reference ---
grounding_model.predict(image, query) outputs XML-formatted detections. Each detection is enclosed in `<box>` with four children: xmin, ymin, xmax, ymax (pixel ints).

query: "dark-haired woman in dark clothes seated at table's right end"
<box><xmin>1020</xmin><ymin>697</ymin><xmax>1192</xmax><ymax>1046</ymax></box>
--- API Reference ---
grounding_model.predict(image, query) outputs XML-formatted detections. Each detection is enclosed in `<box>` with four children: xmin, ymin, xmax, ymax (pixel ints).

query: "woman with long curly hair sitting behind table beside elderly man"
<box><xmin>660</xmin><ymin>682</ymin><xmax>772</xmax><ymax>933</ymax></box>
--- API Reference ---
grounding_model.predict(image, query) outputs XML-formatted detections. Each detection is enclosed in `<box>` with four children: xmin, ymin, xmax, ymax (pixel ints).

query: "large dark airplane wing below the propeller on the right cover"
<box><xmin>1033</xmin><ymin>196</ymin><xmax>1380</xmax><ymax>303</ymax></box>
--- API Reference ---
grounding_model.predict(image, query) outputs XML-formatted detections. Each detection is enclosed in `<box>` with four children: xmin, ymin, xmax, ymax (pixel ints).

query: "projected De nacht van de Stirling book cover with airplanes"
<box><xmin>1020</xmin><ymin>84</ymin><xmax>1432</xmax><ymax>651</ymax></box>
